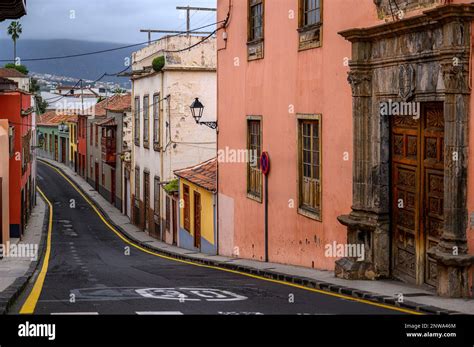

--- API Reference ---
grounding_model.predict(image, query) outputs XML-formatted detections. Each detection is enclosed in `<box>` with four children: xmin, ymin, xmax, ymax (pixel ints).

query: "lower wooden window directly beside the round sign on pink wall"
<box><xmin>247</xmin><ymin>117</ymin><xmax>262</xmax><ymax>202</ymax></box>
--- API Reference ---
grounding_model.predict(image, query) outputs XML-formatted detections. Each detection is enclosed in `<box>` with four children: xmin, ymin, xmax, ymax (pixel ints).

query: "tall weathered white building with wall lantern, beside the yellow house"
<box><xmin>131</xmin><ymin>35</ymin><xmax>217</xmax><ymax>244</ymax></box>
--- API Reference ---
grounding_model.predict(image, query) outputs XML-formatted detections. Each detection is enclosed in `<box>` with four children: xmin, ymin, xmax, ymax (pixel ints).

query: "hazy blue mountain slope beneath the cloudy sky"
<box><xmin>0</xmin><ymin>38</ymin><xmax>141</xmax><ymax>84</ymax></box>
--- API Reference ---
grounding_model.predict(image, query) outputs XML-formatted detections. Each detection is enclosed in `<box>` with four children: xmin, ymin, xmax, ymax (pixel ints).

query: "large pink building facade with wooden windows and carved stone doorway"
<box><xmin>218</xmin><ymin>0</ymin><xmax>474</xmax><ymax>297</ymax></box>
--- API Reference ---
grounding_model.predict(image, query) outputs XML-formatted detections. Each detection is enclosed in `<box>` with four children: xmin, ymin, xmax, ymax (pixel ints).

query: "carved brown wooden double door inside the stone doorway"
<box><xmin>391</xmin><ymin>102</ymin><xmax>444</xmax><ymax>286</ymax></box>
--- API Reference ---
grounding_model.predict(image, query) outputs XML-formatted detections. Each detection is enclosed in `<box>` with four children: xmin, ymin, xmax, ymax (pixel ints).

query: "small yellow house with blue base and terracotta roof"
<box><xmin>174</xmin><ymin>158</ymin><xmax>217</xmax><ymax>254</ymax></box>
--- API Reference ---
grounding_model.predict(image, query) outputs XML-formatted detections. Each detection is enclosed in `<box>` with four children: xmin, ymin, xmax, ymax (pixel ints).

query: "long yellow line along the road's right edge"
<box><xmin>40</xmin><ymin>160</ymin><xmax>423</xmax><ymax>315</ymax></box>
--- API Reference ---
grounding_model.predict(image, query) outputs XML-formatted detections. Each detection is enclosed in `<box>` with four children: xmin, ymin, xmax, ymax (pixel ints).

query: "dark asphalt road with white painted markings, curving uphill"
<box><xmin>12</xmin><ymin>163</ymin><xmax>410</xmax><ymax>315</ymax></box>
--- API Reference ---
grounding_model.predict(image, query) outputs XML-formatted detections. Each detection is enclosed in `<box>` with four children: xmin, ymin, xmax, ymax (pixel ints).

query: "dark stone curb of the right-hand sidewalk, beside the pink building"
<box><xmin>42</xmin><ymin>162</ymin><xmax>463</xmax><ymax>315</ymax></box>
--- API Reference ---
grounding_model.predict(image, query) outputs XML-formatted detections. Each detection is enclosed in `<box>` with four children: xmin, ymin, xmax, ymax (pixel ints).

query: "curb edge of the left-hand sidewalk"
<box><xmin>0</xmin><ymin>194</ymin><xmax>50</xmax><ymax>315</ymax></box>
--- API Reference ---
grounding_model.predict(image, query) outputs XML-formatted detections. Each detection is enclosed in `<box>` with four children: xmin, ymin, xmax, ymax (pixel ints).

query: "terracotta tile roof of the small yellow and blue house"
<box><xmin>174</xmin><ymin>158</ymin><xmax>217</xmax><ymax>193</ymax></box>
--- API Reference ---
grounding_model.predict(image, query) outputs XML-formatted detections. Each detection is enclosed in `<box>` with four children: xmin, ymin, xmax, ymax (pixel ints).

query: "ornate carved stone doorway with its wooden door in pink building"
<box><xmin>335</xmin><ymin>4</ymin><xmax>474</xmax><ymax>297</ymax></box>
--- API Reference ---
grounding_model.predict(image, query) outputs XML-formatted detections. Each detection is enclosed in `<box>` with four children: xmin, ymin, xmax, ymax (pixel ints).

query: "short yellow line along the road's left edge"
<box><xmin>20</xmin><ymin>187</ymin><xmax>53</xmax><ymax>314</ymax></box>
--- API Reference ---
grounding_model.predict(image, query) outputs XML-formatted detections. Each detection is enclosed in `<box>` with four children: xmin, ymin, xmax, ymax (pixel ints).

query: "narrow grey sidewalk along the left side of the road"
<box><xmin>0</xmin><ymin>195</ymin><xmax>48</xmax><ymax>314</ymax></box>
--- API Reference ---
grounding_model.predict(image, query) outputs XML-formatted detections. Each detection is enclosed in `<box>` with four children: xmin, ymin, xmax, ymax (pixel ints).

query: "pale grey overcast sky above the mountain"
<box><xmin>0</xmin><ymin>0</ymin><xmax>216</xmax><ymax>43</ymax></box>
